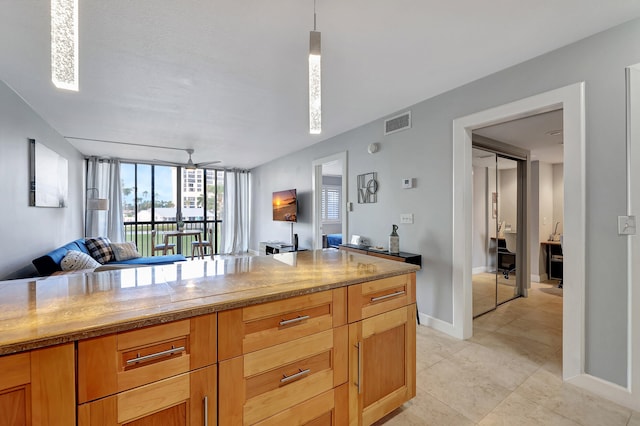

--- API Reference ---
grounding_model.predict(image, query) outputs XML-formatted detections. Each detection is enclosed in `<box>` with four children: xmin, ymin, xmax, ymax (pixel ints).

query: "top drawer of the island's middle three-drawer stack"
<box><xmin>218</xmin><ymin>288</ymin><xmax>347</xmax><ymax>360</ymax></box>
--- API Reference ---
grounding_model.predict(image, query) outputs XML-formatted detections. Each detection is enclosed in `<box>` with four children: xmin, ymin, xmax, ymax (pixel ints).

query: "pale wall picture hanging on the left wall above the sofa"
<box><xmin>29</xmin><ymin>139</ymin><xmax>69</xmax><ymax>207</ymax></box>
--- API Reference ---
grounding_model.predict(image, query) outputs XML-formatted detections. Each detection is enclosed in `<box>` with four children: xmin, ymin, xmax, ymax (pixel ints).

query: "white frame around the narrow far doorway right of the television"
<box><xmin>311</xmin><ymin>151</ymin><xmax>349</xmax><ymax>249</ymax></box>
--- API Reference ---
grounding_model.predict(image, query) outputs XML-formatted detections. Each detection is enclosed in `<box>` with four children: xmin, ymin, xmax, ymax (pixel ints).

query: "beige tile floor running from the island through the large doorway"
<box><xmin>376</xmin><ymin>283</ymin><xmax>640</xmax><ymax>426</ymax></box>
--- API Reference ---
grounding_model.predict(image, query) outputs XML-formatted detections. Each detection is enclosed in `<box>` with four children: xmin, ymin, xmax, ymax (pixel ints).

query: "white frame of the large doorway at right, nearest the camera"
<box><xmin>452</xmin><ymin>82</ymin><xmax>586</xmax><ymax>380</ymax></box>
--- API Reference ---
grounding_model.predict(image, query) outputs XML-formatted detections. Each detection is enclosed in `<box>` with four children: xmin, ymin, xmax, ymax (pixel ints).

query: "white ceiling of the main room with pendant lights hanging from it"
<box><xmin>0</xmin><ymin>0</ymin><xmax>640</xmax><ymax>168</ymax></box>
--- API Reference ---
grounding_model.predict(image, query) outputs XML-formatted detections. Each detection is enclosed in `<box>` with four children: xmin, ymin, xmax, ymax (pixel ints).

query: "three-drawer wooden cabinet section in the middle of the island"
<box><xmin>219</xmin><ymin>288</ymin><xmax>348</xmax><ymax>425</ymax></box>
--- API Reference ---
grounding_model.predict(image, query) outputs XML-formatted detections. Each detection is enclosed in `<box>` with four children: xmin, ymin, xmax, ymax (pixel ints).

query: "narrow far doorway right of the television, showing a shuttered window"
<box><xmin>311</xmin><ymin>151</ymin><xmax>349</xmax><ymax>249</ymax></box>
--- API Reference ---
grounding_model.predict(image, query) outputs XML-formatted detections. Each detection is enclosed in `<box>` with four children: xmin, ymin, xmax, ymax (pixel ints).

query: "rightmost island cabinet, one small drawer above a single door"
<box><xmin>348</xmin><ymin>274</ymin><xmax>416</xmax><ymax>425</ymax></box>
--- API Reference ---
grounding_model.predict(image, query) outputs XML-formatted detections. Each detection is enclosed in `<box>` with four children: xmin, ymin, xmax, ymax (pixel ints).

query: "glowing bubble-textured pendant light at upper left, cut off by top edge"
<box><xmin>51</xmin><ymin>0</ymin><xmax>78</xmax><ymax>92</ymax></box>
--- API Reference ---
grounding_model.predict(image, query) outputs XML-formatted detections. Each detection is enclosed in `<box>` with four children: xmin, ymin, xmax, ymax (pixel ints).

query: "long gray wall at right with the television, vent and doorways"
<box><xmin>251</xmin><ymin>20</ymin><xmax>640</xmax><ymax>385</ymax></box>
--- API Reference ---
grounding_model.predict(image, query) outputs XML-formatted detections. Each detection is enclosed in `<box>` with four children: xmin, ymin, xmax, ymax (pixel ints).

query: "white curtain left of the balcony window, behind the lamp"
<box><xmin>85</xmin><ymin>157</ymin><xmax>124</xmax><ymax>243</ymax></box>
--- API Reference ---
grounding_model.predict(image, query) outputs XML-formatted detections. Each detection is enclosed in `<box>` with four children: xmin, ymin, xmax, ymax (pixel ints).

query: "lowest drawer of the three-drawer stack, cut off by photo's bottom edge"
<box><xmin>256</xmin><ymin>383</ymin><xmax>349</xmax><ymax>426</ymax></box>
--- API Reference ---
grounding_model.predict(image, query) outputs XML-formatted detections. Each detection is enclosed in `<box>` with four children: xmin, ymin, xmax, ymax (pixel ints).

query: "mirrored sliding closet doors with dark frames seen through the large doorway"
<box><xmin>472</xmin><ymin>146</ymin><xmax>529</xmax><ymax>318</ymax></box>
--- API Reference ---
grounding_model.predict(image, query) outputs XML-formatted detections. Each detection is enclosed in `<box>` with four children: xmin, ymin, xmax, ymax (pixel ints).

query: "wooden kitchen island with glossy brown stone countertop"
<box><xmin>0</xmin><ymin>250</ymin><xmax>418</xmax><ymax>425</ymax></box>
